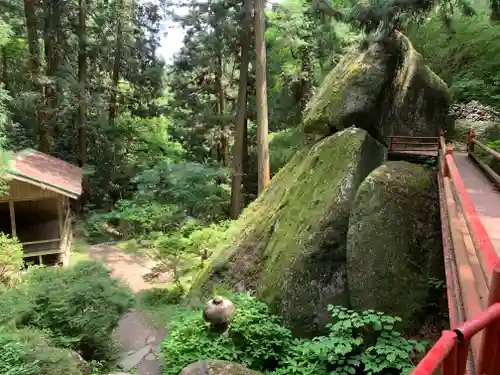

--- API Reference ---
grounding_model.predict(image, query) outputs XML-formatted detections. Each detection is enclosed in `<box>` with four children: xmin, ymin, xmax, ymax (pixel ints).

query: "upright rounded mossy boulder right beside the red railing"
<box><xmin>347</xmin><ymin>161</ymin><xmax>443</xmax><ymax>326</ymax></box>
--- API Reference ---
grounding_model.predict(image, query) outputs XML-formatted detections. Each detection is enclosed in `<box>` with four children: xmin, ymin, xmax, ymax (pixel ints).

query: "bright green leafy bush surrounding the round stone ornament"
<box><xmin>162</xmin><ymin>294</ymin><xmax>292</xmax><ymax>375</ymax></box>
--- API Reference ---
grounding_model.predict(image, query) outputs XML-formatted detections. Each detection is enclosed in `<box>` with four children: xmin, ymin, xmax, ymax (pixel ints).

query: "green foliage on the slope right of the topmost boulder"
<box><xmin>410</xmin><ymin>7</ymin><xmax>500</xmax><ymax>108</ymax></box>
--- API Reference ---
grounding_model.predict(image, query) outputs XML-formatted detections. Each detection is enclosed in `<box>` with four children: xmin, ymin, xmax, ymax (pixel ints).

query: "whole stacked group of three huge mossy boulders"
<box><xmin>191</xmin><ymin>26</ymin><xmax>451</xmax><ymax>336</ymax></box>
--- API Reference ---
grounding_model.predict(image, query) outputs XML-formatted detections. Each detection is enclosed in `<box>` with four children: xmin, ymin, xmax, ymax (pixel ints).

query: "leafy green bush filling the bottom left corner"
<box><xmin>0</xmin><ymin>328</ymin><xmax>86</xmax><ymax>375</ymax></box>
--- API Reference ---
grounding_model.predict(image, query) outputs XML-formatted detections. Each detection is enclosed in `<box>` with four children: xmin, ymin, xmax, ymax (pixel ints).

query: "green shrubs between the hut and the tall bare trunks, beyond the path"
<box><xmin>86</xmin><ymin>162</ymin><xmax>230</xmax><ymax>242</ymax></box>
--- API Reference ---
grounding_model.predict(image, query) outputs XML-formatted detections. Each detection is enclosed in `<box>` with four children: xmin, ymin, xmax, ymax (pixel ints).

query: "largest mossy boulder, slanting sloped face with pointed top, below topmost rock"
<box><xmin>191</xmin><ymin>128</ymin><xmax>385</xmax><ymax>335</ymax></box>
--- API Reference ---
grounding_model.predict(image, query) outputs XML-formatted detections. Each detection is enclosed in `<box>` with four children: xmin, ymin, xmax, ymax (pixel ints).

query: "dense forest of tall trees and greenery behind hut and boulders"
<box><xmin>0</xmin><ymin>0</ymin><xmax>500</xmax><ymax>253</ymax></box>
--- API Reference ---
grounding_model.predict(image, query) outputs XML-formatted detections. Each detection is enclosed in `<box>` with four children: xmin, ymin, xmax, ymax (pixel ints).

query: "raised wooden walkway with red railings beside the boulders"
<box><xmin>388</xmin><ymin>129</ymin><xmax>500</xmax><ymax>375</ymax></box>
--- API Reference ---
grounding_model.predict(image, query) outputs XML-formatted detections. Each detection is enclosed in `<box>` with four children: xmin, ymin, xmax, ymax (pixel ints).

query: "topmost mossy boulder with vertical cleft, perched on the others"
<box><xmin>304</xmin><ymin>33</ymin><xmax>450</xmax><ymax>141</ymax></box>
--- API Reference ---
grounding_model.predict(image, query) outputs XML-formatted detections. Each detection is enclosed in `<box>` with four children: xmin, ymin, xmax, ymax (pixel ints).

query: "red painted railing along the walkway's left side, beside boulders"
<box><xmin>412</xmin><ymin>133</ymin><xmax>500</xmax><ymax>375</ymax></box>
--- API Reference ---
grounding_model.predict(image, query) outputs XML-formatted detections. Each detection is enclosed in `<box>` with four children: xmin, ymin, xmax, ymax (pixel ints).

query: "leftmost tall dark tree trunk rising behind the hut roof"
<box><xmin>24</xmin><ymin>0</ymin><xmax>50</xmax><ymax>153</ymax></box>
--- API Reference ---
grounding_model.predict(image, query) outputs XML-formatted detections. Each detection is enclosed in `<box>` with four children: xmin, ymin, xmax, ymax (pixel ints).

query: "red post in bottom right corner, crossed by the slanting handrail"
<box><xmin>477</xmin><ymin>262</ymin><xmax>500</xmax><ymax>375</ymax></box>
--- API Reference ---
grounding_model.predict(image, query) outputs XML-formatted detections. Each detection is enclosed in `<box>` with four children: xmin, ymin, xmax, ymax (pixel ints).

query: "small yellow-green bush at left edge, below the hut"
<box><xmin>0</xmin><ymin>232</ymin><xmax>23</xmax><ymax>287</ymax></box>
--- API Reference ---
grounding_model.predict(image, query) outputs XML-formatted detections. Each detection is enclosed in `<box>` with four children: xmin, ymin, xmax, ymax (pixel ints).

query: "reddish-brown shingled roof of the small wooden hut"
<box><xmin>9</xmin><ymin>148</ymin><xmax>83</xmax><ymax>199</ymax></box>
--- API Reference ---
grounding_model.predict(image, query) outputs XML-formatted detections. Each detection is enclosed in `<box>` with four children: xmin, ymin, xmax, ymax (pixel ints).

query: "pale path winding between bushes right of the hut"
<box><xmin>89</xmin><ymin>244</ymin><xmax>165</xmax><ymax>375</ymax></box>
